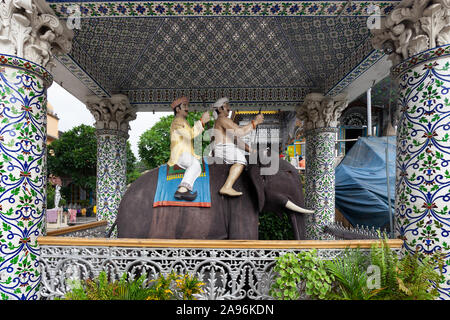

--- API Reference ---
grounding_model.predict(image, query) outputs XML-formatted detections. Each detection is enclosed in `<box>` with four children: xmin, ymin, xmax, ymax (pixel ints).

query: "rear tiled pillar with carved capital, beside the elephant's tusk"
<box><xmin>297</xmin><ymin>93</ymin><xmax>348</xmax><ymax>240</ymax></box>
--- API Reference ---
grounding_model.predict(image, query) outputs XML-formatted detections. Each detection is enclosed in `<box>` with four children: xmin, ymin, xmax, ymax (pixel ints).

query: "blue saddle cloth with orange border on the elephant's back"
<box><xmin>153</xmin><ymin>159</ymin><xmax>211</xmax><ymax>208</ymax></box>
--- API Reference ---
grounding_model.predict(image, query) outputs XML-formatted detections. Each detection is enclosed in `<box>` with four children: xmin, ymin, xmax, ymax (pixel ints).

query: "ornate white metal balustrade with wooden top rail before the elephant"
<box><xmin>38</xmin><ymin>223</ymin><xmax>402</xmax><ymax>300</ymax></box>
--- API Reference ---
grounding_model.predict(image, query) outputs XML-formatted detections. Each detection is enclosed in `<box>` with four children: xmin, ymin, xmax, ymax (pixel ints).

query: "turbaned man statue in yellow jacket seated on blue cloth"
<box><xmin>167</xmin><ymin>97</ymin><xmax>210</xmax><ymax>201</ymax></box>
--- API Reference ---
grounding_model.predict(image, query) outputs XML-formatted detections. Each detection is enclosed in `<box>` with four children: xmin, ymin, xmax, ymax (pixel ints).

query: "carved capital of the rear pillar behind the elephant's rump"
<box><xmin>86</xmin><ymin>94</ymin><xmax>137</xmax><ymax>134</ymax></box>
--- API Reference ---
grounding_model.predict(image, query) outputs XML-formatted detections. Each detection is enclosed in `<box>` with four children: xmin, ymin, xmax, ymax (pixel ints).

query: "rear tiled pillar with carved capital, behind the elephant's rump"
<box><xmin>86</xmin><ymin>94</ymin><xmax>136</xmax><ymax>236</ymax></box>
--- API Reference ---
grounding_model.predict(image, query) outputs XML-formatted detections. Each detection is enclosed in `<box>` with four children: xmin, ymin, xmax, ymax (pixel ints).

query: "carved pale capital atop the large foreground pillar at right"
<box><xmin>371</xmin><ymin>0</ymin><xmax>450</xmax><ymax>65</ymax></box>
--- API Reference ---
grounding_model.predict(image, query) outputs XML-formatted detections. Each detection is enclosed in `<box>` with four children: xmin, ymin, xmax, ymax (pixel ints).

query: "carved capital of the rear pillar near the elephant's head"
<box><xmin>296</xmin><ymin>93</ymin><xmax>348</xmax><ymax>131</ymax></box>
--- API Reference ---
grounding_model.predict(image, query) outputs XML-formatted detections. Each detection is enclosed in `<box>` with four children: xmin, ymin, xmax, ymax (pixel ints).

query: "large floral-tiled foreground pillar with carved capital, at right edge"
<box><xmin>372</xmin><ymin>0</ymin><xmax>450</xmax><ymax>299</ymax></box>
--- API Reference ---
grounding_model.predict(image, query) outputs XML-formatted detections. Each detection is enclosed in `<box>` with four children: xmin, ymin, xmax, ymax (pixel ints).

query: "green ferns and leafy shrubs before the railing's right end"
<box><xmin>270</xmin><ymin>239</ymin><xmax>444</xmax><ymax>300</ymax></box>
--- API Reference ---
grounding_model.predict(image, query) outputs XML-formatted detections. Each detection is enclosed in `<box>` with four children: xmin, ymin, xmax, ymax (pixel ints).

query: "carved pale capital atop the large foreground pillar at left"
<box><xmin>0</xmin><ymin>0</ymin><xmax>74</xmax><ymax>68</ymax></box>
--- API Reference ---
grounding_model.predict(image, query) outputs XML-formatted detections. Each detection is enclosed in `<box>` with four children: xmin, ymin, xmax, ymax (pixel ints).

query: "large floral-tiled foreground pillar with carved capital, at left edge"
<box><xmin>0</xmin><ymin>0</ymin><xmax>73</xmax><ymax>300</ymax></box>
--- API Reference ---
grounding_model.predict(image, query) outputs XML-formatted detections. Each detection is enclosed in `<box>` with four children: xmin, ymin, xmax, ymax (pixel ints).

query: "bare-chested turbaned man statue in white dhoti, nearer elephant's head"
<box><xmin>213</xmin><ymin>98</ymin><xmax>264</xmax><ymax>197</ymax></box>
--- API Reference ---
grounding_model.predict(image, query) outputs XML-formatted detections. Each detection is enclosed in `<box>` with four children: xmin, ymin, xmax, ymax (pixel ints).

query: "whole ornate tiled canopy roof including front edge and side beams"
<box><xmin>48</xmin><ymin>0</ymin><xmax>398</xmax><ymax>111</ymax></box>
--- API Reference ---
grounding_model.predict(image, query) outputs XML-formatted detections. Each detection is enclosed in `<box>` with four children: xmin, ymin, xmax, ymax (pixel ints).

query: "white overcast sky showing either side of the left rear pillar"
<box><xmin>47</xmin><ymin>82</ymin><xmax>171</xmax><ymax>159</ymax></box>
